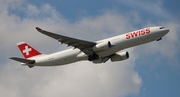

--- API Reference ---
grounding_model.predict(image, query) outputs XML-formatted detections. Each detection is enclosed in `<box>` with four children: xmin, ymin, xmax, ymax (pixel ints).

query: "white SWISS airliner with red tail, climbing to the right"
<box><xmin>10</xmin><ymin>26</ymin><xmax>170</xmax><ymax>68</ymax></box>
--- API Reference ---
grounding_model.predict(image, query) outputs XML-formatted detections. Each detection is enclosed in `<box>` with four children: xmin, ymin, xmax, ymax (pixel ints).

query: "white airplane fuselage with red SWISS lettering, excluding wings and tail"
<box><xmin>26</xmin><ymin>27</ymin><xmax>169</xmax><ymax>66</ymax></box>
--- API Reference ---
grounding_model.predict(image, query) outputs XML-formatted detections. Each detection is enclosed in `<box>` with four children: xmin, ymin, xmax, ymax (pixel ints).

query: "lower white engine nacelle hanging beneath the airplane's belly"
<box><xmin>111</xmin><ymin>52</ymin><xmax>129</xmax><ymax>62</ymax></box>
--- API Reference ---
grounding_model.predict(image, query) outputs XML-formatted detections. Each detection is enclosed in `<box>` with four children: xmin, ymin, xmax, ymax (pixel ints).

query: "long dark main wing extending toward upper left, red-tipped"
<box><xmin>36</xmin><ymin>27</ymin><xmax>96</xmax><ymax>55</ymax></box>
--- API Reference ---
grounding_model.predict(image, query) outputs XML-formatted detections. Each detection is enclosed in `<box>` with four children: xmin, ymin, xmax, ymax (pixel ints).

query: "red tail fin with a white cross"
<box><xmin>17</xmin><ymin>42</ymin><xmax>41</xmax><ymax>59</ymax></box>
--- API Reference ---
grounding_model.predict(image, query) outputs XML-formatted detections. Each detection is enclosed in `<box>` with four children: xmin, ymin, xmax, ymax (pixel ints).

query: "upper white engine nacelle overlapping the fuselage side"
<box><xmin>93</xmin><ymin>41</ymin><xmax>111</xmax><ymax>51</ymax></box>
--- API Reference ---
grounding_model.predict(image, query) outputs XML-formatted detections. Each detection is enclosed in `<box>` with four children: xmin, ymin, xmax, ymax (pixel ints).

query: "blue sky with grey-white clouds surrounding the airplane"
<box><xmin>0</xmin><ymin>0</ymin><xmax>180</xmax><ymax>97</ymax></box>
